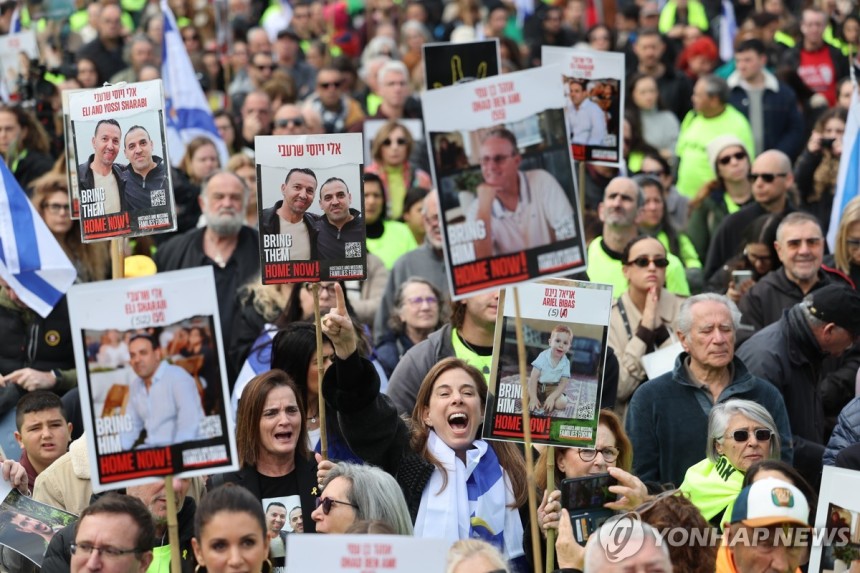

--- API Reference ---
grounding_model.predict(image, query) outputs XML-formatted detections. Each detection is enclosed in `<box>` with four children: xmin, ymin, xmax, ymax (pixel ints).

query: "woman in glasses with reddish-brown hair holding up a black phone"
<box><xmin>523</xmin><ymin>410</ymin><xmax>648</xmax><ymax>570</ymax></box>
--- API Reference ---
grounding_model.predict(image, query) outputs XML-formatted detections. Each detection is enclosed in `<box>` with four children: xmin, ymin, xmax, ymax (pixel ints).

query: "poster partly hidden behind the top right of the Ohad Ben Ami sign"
<box><xmin>541</xmin><ymin>46</ymin><xmax>625</xmax><ymax>167</ymax></box>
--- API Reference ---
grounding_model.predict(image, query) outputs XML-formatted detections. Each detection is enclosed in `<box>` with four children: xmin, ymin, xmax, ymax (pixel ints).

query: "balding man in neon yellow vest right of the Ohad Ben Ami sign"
<box><xmin>588</xmin><ymin>177</ymin><xmax>690</xmax><ymax>297</ymax></box>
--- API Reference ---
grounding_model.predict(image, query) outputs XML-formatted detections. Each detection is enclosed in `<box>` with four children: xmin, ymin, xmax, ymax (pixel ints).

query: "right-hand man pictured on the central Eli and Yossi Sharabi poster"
<box><xmin>317</xmin><ymin>177</ymin><xmax>365</xmax><ymax>259</ymax></box>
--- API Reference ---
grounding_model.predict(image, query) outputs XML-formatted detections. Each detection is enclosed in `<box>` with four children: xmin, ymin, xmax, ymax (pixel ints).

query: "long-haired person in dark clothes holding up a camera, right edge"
<box><xmin>794</xmin><ymin>107</ymin><xmax>848</xmax><ymax>236</ymax></box>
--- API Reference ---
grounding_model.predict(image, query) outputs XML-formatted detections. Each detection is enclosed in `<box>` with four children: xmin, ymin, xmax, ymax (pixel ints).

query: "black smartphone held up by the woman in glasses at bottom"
<box><xmin>561</xmin><ymin>474</ymin><xmax>618</xmax><ymax>545</ymax></box>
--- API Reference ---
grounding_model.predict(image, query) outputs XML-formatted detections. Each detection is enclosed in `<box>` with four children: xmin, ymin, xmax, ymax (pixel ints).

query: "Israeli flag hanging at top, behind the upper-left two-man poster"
<box><xmin>161</xmin><ymin>0</ymin><xmax>229</xmax><ymax>167</ymax></box>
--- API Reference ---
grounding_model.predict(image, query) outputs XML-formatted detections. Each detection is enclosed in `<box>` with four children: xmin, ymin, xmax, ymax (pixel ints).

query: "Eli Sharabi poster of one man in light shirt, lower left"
<box><xmin>68</xmin><ymin>267</ymin><xmax>238</xmax><ymax>491</ymax></box>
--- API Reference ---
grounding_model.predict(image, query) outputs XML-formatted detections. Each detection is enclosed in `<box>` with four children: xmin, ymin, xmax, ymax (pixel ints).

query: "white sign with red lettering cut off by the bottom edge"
<box><xmin>286</xmin><ymin>535</ymin><xmax>449</xmax><ymax>573</ymax></box>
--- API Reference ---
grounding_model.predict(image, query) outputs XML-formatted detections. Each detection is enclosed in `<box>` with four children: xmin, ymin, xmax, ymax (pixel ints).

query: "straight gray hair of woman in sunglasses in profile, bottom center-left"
<box><xmin>323</xmin><ymin>462</ymin><xmax>412</xmax><ymax>535</ymax></box>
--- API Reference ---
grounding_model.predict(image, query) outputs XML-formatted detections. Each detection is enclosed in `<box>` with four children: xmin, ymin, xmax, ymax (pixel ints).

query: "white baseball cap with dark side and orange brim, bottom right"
<box><xmin>731</xmin><ymin>478</ymin><xmax>809</xmax><ymax>527</ymax></box>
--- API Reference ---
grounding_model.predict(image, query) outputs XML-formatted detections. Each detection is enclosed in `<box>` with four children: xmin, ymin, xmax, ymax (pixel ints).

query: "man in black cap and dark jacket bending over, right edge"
<box><xmin>738</xmin><ymin>284</ymin><xmax>860</xmax><ymax>484</ymax></box>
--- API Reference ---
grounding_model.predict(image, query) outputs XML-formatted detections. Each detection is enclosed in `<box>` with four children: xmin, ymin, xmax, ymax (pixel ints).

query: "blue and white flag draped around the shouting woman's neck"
<box><xmin>415</xmin><ymin>431</ymin><xmax>523</xmax><ymax>559</ymax></box>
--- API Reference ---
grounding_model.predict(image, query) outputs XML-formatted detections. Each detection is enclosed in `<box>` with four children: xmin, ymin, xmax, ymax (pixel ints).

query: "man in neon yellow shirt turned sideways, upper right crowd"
<box><xmin>675</xmin><ymin>75</ymin><xmax>755</xmax><ymax>199</ymax></box>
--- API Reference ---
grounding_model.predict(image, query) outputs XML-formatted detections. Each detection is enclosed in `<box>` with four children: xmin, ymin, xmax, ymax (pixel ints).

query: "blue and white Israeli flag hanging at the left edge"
<box><xmin>0</xmin><ymin>161</ymin><xmax>78</xmax><ymax>318</ymax></box>
